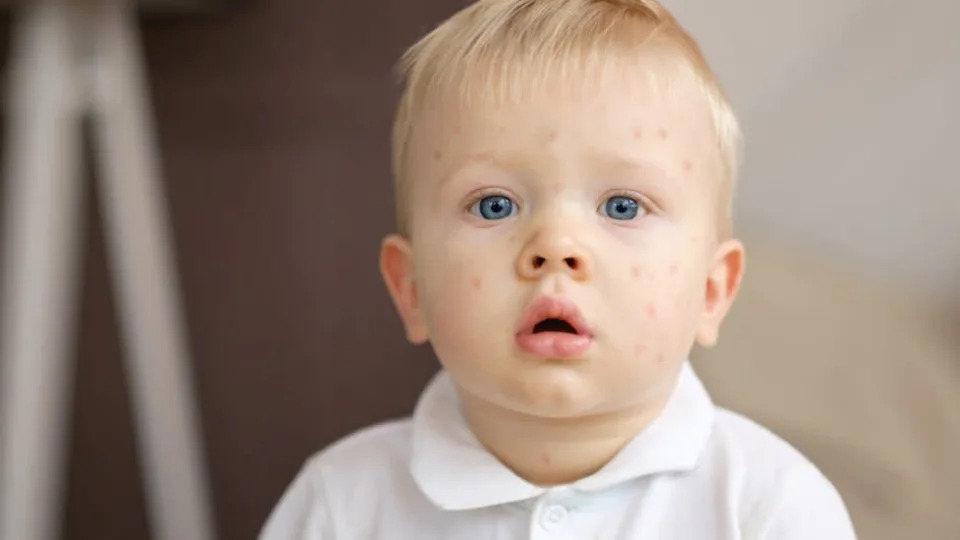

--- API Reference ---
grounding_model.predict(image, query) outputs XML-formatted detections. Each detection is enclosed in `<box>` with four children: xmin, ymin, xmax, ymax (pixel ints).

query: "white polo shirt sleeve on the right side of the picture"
<box><xmin>744</xmin><ymin>463</ymin><xmax>856</xmax><ymax>540</ymax></box>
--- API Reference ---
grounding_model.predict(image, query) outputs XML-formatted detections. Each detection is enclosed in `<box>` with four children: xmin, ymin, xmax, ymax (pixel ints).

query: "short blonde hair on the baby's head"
<box><xmin>393</xmin><ymin>0</ymin><xmax>742</xmax><ymax>235</ymax></box>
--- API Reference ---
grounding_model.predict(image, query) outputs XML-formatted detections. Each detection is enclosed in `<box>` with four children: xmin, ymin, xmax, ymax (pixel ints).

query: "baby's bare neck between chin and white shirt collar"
<box><xmin>460</xmin><ymin>391</ymin><xmax>667</xmax><ymax>486</ymax></box>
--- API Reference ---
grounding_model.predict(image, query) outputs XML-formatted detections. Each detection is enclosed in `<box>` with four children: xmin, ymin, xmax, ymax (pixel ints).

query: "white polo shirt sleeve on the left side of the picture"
<box><xmin>259</xmin><ymin>460</ymin><xmax>335</xmax><ymax>540</ymax></box>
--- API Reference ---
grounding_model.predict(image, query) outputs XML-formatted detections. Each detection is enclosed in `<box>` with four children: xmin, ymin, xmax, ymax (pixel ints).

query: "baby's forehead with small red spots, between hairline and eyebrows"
<box><xmin>409</xmin><ymin>50</ymin><xmax>716</xmax><ymax>172</ymax></box>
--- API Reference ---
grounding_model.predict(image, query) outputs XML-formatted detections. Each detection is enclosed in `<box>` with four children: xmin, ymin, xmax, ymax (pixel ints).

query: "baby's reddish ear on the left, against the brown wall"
<box><xmin>380</xmin><ymin>234</ymin><xmax>427</xmax><ymax>345</ymax></box>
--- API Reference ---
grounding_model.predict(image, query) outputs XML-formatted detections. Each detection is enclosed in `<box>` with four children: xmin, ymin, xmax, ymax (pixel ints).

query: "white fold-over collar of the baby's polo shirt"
<box><xmin>410</xmin><ymin>363</ymin><xmax>715</xmax><ymax>510</ymax></box>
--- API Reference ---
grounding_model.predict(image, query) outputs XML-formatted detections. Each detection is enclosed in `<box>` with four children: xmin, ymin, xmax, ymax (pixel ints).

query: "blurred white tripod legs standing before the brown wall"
<box><xmin>0</xmin><ymin>0</ymin><xmax>215</xmax><ymax>540</ymax></box>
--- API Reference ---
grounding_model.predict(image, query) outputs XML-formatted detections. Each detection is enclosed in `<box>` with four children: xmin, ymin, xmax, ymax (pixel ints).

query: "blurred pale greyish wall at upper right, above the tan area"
<box><xmin>666</xmin><ymin>0</ymin><xmax>960</xmax><ymax>309</ymax></box>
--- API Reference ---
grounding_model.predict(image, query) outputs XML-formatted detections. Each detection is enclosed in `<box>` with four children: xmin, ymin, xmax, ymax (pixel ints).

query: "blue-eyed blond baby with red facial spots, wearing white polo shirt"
<box><xmin>261</xmin><ymin>0</ymin><xmax>854</xmax><ymax>540</ymax></box>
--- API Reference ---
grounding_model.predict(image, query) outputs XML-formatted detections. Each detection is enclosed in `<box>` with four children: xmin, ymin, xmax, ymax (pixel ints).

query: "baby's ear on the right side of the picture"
<box><xmin>697</xmin><ymin>239</ymin><xmax>746</xmax><ymax>347</ymax></box>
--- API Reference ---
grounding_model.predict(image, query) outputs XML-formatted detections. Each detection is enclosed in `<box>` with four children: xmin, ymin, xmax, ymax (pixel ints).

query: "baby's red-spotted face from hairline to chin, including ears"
<box><xmin>385</xmin><ymin>58</ymin><xmax>740</xmax><ymax>417</ymax></box>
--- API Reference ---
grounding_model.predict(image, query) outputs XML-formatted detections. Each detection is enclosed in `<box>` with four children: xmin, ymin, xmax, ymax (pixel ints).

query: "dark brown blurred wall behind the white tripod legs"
<box><xmin>5</xmin><ymin>0</ymin><xmax>462</xmax><ymax>540</ymax></box>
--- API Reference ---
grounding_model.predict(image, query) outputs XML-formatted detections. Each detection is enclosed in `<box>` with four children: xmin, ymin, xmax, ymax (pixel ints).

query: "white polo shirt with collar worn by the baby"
<box><xmin>260</xmin><ymin>365</ymin><xmax>855</xmax><ymax>540</ymax></box>
